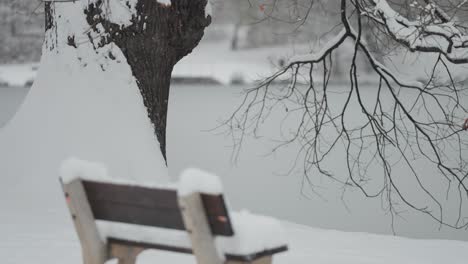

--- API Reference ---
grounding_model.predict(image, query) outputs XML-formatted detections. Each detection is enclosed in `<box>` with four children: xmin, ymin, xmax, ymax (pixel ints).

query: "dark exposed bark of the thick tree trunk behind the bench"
<box><xmin>45</xmin><ymin>0</ymin><xmax>211</xmax><ymax>162</ymax></box>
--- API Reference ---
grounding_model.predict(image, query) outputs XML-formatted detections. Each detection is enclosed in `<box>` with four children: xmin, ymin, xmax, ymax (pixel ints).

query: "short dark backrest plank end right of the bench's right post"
<box><xmin>201</xmin><ymin>194</ymin><xmax>234</xmax><ymax>236</ymax></box>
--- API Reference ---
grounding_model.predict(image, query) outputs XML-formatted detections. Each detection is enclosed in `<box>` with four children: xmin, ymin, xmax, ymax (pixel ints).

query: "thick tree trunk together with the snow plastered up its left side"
<box><xmin>0</xmin><ymin>0</ymin><xmax>211</xmax><ymax>206</ymax></box>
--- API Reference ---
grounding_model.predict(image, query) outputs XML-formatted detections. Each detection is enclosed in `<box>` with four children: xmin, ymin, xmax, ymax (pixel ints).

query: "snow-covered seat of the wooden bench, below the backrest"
<box><xmin>96</xmin><ymin>209</ymin><xmax>287</xmax><ymax>262</ymax></box>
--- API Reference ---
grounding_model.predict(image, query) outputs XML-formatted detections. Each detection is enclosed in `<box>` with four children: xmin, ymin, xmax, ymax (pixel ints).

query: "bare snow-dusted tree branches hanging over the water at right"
<box><xmin>225</xmin><ymin>0</ymin><xmax>468</xmax><ymax>231</ymax></box>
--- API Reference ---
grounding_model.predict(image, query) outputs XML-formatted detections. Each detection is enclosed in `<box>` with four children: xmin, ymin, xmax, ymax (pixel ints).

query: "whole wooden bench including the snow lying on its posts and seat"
<box><xmin>60</xmin><ymin>159</ymin><xmax>287</xmax><ymax>264</ymax></box>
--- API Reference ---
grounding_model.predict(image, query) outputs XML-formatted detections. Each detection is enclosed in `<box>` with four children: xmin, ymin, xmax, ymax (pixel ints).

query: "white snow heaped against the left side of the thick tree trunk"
<box><xmin>0</xmin><ymin>1</ymin><xmax>169</xmax><ymax>196</ymax></box>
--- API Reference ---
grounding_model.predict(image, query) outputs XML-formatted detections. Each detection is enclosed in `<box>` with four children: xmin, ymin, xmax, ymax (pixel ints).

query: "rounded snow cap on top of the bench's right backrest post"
<box><xmin>178</xmin><ymin>169</ymin><xmax>223</xmax><ymax>196</ymax></box>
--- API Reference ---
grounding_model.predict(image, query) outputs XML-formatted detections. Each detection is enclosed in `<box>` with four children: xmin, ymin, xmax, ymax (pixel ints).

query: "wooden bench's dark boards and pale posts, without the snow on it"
<box><xmin>62</xmin><ymin>179</ymin><xmax>287</xmax><ymax>264</ymax></box>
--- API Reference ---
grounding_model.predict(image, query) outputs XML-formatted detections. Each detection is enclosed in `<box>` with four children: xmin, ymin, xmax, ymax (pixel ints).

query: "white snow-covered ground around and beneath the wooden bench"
<box><xmin>0</xmin><ymin>155</ymin><xmax>468</xmax><ymax>264</ymax></box>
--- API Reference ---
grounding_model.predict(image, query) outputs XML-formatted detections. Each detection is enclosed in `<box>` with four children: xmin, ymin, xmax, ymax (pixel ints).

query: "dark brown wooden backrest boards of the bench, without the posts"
<box><xmin>82</xmin><ymin>181</ymin><xmax>234</xmax><ymax>236</ymax></box>
